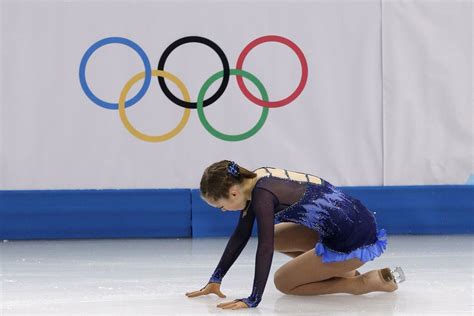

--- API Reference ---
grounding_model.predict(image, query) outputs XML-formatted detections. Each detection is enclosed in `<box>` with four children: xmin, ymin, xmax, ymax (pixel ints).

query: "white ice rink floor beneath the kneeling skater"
<box><xmin>0</xmin><ymin>235</ymin><xmax>474</xmax><ymax>316</ymax></box>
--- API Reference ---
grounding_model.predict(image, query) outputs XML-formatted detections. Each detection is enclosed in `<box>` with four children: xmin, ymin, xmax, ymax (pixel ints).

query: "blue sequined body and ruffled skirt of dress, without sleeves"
<box><xmin>287</xmin><ymin>183</ymin><xmax>387</xmax><ymax>262</ymax></box>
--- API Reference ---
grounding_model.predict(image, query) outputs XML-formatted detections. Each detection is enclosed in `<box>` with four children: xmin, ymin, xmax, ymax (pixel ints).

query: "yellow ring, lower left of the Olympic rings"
<box><xmin>118</xmin><ymin>70</ymin><xmax>191</xmax><ymax>142</ymax></box>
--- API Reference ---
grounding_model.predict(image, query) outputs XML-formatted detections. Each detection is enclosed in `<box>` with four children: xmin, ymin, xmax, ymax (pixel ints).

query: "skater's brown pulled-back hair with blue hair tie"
<box><xmin>200</xmin><ymin>160</ymin><xmax>257</xmax><ymax>200</ymax></box>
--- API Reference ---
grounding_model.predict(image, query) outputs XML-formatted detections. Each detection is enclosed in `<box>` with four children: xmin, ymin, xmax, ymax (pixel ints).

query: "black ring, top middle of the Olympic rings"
<box><xmin>158</xmin><ymin>36</ymin><xmax>230</xmax><ymax>109</ymax></box>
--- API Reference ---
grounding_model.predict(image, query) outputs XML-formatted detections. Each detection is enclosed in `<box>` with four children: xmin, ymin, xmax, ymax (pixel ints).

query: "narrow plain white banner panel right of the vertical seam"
<box><xmin>382</xmin><ymin>1</ymin><xmax>474</xmax><ymax>185</ymax></box>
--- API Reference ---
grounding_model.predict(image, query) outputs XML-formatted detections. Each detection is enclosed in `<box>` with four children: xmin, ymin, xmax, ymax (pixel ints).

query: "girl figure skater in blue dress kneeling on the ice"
<box><xmin>186</xmin><ymin>160</ymin><xmax>405</xmax><ymax>309</ymax></box>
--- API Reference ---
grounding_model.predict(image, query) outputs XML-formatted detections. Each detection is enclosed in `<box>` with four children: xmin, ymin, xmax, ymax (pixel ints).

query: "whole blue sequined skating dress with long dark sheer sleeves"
<box><xmin>209</xmin><ymin>168</ymin><xmax>387</xmax><ymax>307</ymax></box>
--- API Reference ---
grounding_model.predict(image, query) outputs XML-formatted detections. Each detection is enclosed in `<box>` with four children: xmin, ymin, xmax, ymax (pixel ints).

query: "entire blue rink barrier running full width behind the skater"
<box><xmin>0</xmin><ymin>185</ymin><xmax>474</xmax><ymax>240</ymax></box>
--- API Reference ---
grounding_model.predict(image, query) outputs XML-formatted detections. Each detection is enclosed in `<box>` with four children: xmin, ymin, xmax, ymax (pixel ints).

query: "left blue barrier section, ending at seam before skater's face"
<box><xmin>0</xmin><ymin>189</ymin><xmax>191</xmax><ymax>240</ymax></box>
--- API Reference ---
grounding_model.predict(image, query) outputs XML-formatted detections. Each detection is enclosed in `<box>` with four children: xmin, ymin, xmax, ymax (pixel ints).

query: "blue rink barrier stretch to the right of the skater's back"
<box><xmin>341</xmin><ymin>185</ymin><xmax>474</xmax><ymax>234</ymax></box>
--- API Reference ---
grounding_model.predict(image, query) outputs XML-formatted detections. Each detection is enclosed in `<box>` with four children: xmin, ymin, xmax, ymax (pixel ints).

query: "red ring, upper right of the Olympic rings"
<box><xmin>235</xmin><ymin>35</ymin><xmax>308</xmax><ymax>108</ymax></box>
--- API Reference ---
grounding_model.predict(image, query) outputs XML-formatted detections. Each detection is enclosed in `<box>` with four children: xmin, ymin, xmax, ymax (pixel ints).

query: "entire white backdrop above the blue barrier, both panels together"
<box><xmin>0</xmin><ymin>1</ymin><xmax>473</xmax><ymax>189</ymax></box>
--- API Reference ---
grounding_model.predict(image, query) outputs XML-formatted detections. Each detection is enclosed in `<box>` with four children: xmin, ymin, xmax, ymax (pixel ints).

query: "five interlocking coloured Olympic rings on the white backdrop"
<box><xmin>79</xmin><ymin>35</ymin><xmax>308</xmax><ymax>142</ymax></box>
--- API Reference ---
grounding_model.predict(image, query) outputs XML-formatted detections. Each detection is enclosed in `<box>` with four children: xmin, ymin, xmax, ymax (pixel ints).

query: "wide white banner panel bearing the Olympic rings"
<box><xmin>1</xmin><ymin>1</ymin><xmax>382</xmax><ymax>189</ymax></box>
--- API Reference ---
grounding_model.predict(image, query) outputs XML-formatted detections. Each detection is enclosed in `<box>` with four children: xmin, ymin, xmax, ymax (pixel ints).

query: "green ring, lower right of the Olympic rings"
<box><xmin>196</xmin><ymin>69</ymin><xmax>269</xmax><ymax>142</ymax></box>
